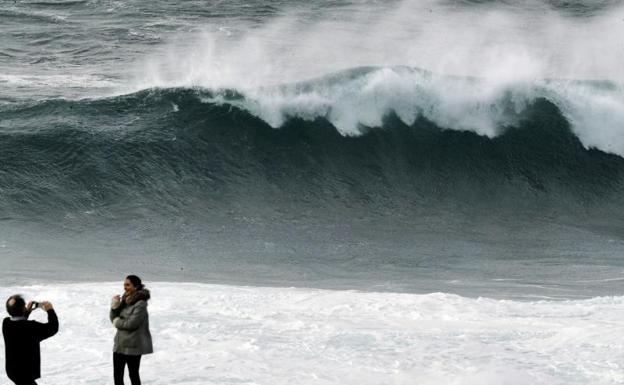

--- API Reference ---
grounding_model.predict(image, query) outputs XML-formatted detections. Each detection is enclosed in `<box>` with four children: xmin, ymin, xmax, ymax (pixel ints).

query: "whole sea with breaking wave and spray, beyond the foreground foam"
<box><xmin>0</xmin><ymin>0</ymin><xmax>624</xmax><ymax>298</ymax></box>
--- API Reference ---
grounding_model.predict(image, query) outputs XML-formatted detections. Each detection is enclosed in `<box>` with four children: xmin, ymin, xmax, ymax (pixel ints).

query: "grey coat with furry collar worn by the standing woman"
<box><xmin>110</xmin><ymin>289</ymin><xmax>154</xmax><ymax>356</ymax></box>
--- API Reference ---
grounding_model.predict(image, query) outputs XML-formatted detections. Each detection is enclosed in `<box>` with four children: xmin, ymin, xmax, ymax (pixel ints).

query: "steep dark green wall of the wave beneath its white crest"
<box><xmin>0</xmin><ymin>85</ymin><xmax>624</xmax><ymax>217</ymax></box>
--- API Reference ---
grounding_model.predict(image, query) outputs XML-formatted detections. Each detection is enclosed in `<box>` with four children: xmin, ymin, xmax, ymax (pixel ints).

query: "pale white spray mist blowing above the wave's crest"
<box><xmin>137</xmin><ymin>0</ymin><xmax>624</xmax><ymax>89</ymax></box>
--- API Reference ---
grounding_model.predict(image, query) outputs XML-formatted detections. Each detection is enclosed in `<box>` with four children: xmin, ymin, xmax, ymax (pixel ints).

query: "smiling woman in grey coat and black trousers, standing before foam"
<box><xmin>110</xmin><ymin>275</ymin><xmax>154</xmax><ymax>385</ymax></box>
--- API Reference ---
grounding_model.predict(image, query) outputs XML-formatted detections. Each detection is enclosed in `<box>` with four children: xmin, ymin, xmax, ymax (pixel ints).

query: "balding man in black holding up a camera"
<box><xmin>2</xmin><ymin>295</ymin><xmax>58</xmax><ymax>385</ymax></box>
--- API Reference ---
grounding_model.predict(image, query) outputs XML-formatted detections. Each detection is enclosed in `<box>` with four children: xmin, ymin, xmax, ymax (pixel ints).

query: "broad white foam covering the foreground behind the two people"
<box><xmin>0</xmin><ymin>283</ymin><xmax>624</xmax><ymax>385</ymax></box>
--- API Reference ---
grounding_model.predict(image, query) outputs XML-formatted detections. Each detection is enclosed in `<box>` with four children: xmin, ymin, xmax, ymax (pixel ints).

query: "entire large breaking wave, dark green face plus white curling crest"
<box><xmin>0</xmin><ymin>67</ymin><xmax>624</xmax><ymax>222</ymax></box>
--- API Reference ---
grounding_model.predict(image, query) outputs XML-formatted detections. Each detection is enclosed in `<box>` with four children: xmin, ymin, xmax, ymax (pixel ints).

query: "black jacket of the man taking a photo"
<box><xmin>2</xmin><ymin>309</ymin><xmax>58</xmax><ymax>382</ymax></box>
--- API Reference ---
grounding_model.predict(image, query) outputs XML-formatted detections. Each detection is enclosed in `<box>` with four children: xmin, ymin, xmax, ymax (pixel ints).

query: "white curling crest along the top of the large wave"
<box><xmin>195</xmin><ymin>67</ymin><xmax>624</xmax><ymax>156</ymax></box>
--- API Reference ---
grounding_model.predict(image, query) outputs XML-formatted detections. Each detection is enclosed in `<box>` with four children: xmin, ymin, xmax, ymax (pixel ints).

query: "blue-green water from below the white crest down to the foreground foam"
<box><xmin>0</xmin><ymin>89</ymin><xmax>624</xmax><ymax>296</ymax></box>
